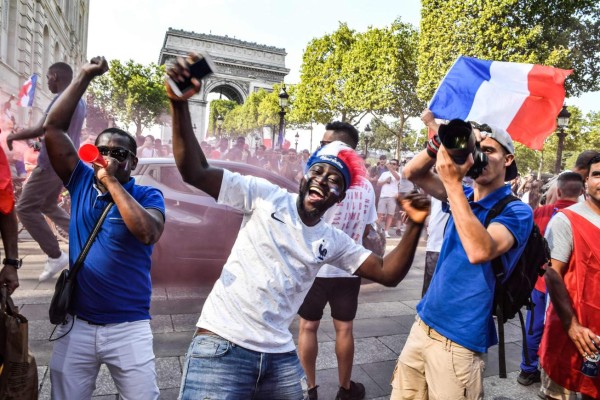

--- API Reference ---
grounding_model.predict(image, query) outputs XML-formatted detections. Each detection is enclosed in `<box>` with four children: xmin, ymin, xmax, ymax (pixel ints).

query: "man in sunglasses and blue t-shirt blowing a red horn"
<box><xmin>44</xmin><ymin>58</ymin><xmax>165</xmax><ymax>399</ymax></box>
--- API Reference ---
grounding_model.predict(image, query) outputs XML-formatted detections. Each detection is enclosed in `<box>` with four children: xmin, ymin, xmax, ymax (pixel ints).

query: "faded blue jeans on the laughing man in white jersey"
<box><xmin>179</xmin><ymin>333</ymin><xmax>307</xmax><ymax>400</ymax></box>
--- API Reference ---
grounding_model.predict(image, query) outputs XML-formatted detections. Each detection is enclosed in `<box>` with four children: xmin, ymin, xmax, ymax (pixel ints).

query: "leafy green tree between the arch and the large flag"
<box><xmin>292</xmin><ymin>19</ymin><xmax>424</xmax><ymax>158</ymax></box>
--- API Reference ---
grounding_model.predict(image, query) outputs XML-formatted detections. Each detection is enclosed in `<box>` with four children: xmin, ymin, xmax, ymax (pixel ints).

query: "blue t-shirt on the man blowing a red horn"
<box><xmin>66</xmin><ymin>162</ymin><xmax>165</xmax><ymax>324</ymax></box>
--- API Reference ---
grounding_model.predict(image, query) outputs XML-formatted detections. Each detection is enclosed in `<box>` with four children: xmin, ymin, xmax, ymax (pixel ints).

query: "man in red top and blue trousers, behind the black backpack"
<box><xmin>517</xmin><ymin>171</ymin><xmax>584</xmax><ymax>386</ymax></box>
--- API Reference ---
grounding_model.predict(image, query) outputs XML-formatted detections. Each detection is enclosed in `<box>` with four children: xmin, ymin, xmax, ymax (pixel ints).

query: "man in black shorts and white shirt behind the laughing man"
<box><xmin>298</xmin><ymin>121</ymin><xmax>377</xmax><ymax>400</ymax></box>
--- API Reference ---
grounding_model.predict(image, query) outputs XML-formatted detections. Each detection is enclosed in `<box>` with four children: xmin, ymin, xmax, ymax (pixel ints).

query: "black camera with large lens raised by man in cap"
<box><xmin>438</xmin><ymin>119</ymin><xmax>488</xmax><ymax>179</ymax></box>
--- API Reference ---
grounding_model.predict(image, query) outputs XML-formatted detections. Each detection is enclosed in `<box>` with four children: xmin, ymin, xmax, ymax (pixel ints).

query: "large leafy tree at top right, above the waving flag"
<box><xmin>418</xmin><ymin>0</ymin><xmax>600</xmax><ymax>100</ymax></box>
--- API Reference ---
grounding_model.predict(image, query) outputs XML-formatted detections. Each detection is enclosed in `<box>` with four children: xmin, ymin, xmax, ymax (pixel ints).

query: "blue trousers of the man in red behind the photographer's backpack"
<box><xmin>521</xmin><ymin>289</ymin><xmax>546</xmax><ymax>373</ymax></box>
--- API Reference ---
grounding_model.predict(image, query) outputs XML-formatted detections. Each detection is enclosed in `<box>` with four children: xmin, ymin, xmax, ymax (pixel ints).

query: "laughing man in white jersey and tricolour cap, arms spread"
<box><xmin>167</xmin><ymin>60</ymin><xmax>428</xmax><ymax>400</ymax></box>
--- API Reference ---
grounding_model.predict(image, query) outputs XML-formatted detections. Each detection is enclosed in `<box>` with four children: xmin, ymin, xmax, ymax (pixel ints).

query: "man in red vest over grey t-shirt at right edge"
<box><xmin>540</xmin><ymin>155</ymin><xmax>600</xmax><ymax>400</ymax></box>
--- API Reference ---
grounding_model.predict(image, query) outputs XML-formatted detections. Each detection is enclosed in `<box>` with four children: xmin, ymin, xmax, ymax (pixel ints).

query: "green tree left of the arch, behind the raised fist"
<box><xmin>90</xmin><ymin>60</ymin><xmax>168</xmax><ymax>137</ymax></box>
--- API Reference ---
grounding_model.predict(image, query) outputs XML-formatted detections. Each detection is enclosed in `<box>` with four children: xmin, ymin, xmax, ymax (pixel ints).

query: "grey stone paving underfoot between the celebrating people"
<box><xmin>13</xmin><ymin>232</ymin><xmax>539</xmax><ymax>400</ymax></box>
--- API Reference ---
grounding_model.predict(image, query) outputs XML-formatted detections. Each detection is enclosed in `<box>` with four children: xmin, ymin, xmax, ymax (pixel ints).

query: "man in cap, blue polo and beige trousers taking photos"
<box><xmin>391</xmin><ymin>112</ymin><xmax>533</xmax><ymax>399</ymax></box>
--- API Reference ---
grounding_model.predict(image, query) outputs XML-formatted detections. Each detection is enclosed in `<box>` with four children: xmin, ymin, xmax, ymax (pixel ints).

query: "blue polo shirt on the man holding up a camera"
<box><xmin>417</xmin><ymin>185</ymin><xmax>533</xmax><ymax>353</ymax></box>
